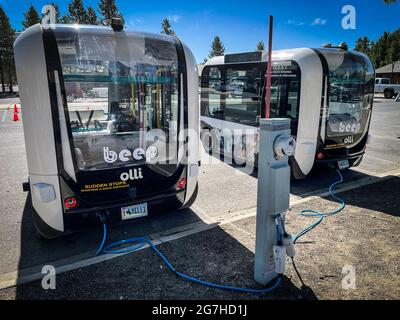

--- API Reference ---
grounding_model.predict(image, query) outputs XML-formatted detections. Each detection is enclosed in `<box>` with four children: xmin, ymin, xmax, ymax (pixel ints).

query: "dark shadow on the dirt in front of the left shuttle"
<box><xmin>16</xmin><ymin>222</ymin><xmax>316</xmax><ymax>300</ymax></box>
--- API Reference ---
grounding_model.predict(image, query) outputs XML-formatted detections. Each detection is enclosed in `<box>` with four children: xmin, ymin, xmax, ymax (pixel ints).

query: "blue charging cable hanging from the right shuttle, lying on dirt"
<box><xmin>293</xmin><ymin>169</ymin><xmax>346</xmax><ymax>243</ymax></box>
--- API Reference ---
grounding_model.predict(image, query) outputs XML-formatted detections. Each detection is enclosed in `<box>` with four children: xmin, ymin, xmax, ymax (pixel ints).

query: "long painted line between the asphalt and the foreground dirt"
<box><xmin>0</xmin><ymin>170</ymin><xmax>400</xmax><ymax>289</ymax></box>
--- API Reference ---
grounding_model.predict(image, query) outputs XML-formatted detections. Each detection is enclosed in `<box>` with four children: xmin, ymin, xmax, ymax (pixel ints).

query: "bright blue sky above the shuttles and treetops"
<box><xmin>0</xmin><ymin>0</ymin><xmax>400</xmax><ymax>62</ymax></box>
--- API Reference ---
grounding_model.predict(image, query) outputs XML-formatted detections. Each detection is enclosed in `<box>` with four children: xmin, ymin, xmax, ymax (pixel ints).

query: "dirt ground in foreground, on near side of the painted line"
<box><xmin>0</xmin><ymin>177</ymin><xmax>400</xmax><ymax>299</ymax></box>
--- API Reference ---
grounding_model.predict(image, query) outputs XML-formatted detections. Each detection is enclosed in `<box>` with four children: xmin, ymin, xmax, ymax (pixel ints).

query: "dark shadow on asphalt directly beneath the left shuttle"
<box><xmin>14</xmin><ymin>193</ymin><xmax>206</xmax><ymax>277</ymax></box>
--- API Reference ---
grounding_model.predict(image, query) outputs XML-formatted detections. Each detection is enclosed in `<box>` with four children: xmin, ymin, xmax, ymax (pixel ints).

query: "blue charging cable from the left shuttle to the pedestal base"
<box><xmin>96</xmin><ymin>223</ymin><xmax>281</xmax><ymax>294</ymax></box>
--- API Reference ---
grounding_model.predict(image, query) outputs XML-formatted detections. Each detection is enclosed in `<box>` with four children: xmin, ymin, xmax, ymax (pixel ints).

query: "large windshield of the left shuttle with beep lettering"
<box><xmin>56</xmin><ymin>31</ymin><xmax>179</xmax><ymax>170</ymax></box>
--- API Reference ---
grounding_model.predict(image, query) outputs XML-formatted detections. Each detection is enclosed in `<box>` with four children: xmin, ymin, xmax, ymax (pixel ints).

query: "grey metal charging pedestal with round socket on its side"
<box><xmin>254</xmin><ymin>118</ymin><xmax>295</xmax><ymax>285</ymax></box>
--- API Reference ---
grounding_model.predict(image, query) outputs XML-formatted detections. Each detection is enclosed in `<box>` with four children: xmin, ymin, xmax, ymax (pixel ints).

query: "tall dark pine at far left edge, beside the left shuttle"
<box><xmin>0</xmin><ymin>6</ymin><xmax>16</xmax><ymax>93</ymax></box>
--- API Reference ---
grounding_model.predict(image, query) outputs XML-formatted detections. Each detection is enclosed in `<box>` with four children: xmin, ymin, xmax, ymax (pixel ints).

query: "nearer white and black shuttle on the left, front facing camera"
<box><xmin>14</xmin><ymin>24</ymin><xmax>200</xmax><ymax>238</ymax></box>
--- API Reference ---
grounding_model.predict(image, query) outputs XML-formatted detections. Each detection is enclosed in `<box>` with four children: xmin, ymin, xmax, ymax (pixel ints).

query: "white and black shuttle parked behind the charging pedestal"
<box><xmin>201</xmin><ymin>44</ymin><xmax>375</xmax><ymax>179</ymax></box>
